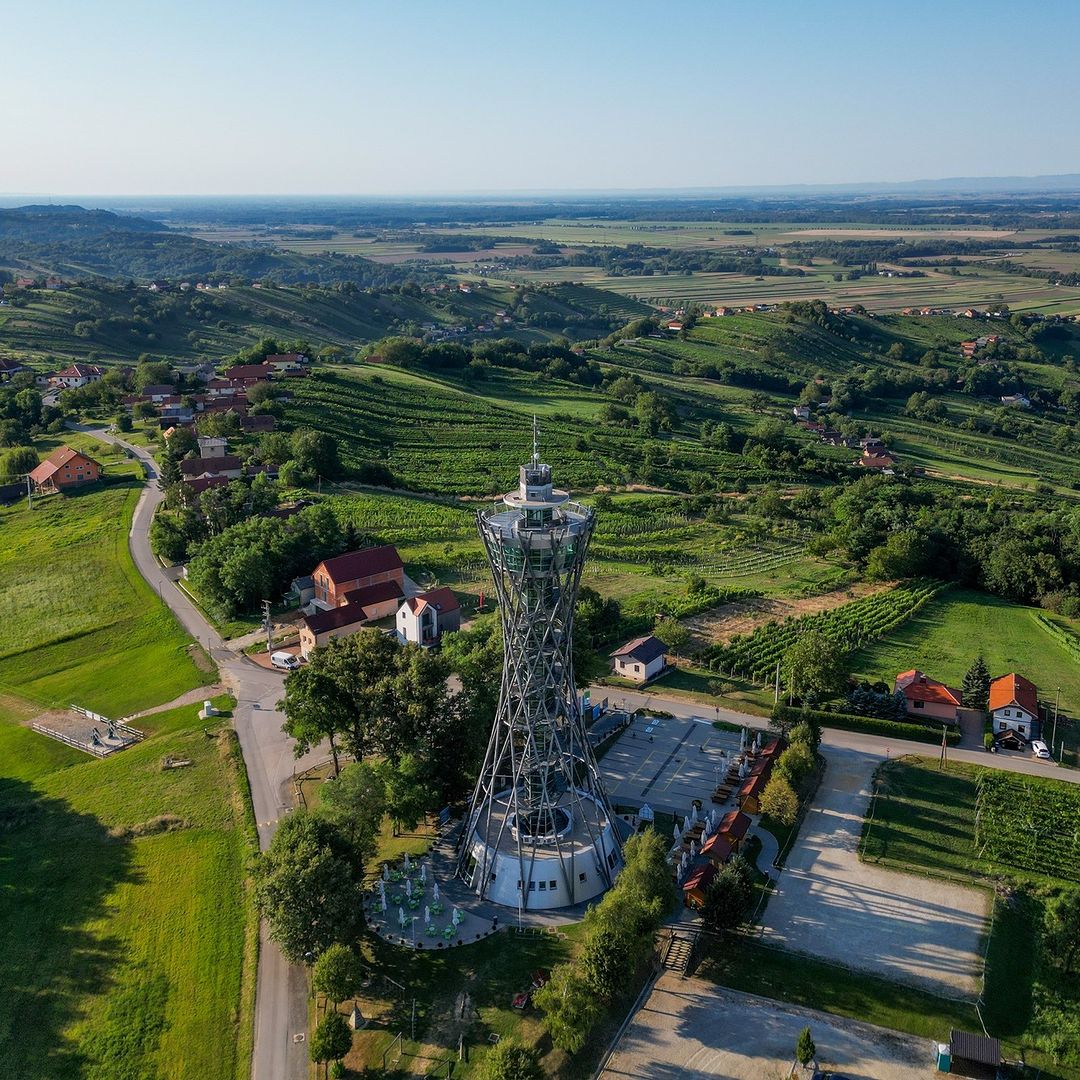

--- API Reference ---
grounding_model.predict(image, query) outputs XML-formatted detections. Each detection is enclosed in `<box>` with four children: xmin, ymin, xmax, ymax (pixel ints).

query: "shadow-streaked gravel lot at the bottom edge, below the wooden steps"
<box><xmin>600</xmin><ymin>973</ymin><xmax>933</xmax><ymax>1080</ymax></box>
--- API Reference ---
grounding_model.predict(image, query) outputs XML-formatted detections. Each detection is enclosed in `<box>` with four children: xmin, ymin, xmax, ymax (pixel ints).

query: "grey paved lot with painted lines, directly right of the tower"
<box><xmin>600</xmin><ymin>716</ymin><xmax>739</xmax><ymax>818</ymax></box>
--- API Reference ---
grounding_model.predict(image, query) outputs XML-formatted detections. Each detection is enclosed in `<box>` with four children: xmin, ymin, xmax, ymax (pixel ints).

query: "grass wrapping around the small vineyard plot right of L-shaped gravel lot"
<box><xmin>863</xmin><ymin>758</ymin><xmax>1080</xmax><ymax>1077</ymax></box>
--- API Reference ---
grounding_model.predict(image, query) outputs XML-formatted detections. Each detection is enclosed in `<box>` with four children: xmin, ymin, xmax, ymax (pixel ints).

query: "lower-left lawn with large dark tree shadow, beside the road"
<box><xmin>0</xmin><ymin>699</ymin><xmax>257</xmax><ymax>1080</ymax></box>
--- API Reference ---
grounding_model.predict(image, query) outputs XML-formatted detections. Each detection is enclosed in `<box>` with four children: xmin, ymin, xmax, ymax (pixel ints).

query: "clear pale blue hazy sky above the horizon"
<box><xmin>8</xmin><ymin>0</ymin><xmax>1080</xmax><ymax>195</ymax></box>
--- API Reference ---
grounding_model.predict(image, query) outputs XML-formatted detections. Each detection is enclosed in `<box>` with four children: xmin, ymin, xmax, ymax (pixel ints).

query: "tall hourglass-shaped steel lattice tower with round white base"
<box><xmin>458</xmin><ymin>421</ymin><xmax>622</xmax><ymax>908</ymax></box>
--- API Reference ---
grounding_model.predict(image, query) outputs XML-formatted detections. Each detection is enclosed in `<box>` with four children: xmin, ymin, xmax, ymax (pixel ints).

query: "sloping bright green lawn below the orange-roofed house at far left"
<box><xmin>0</xmin><ymin>475</ymin><xmax>213</xmax><ymax>717</ymax></box>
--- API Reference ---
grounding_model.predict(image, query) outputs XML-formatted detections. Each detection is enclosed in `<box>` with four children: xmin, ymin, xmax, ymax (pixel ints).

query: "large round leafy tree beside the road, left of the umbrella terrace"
<box><xmin>255</xmin><ymin>812</ymin><xmax>363</xmax><ymax>963</ymax></box>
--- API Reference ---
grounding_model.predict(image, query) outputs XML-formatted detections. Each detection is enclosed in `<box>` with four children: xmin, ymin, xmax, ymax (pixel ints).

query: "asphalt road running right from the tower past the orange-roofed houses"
<box><xmin>590</xmin><ymin>686</ymin><xmax>1080</xmax><ymax>784</ymax></box>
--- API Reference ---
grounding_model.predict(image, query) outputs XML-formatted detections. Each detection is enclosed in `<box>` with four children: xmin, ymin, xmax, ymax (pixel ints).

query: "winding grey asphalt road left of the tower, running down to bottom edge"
<box><xmin>79</xmin><ymin>427</ymin><xmax>308</xmax><ymax>1080</ymax></box>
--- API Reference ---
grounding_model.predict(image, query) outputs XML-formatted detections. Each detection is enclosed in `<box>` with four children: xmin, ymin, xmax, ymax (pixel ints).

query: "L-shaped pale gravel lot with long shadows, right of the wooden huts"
<box><xmin>765</xmin><ymin>750</ymin><xmax>989</xmax><ymax>998</ymax></box>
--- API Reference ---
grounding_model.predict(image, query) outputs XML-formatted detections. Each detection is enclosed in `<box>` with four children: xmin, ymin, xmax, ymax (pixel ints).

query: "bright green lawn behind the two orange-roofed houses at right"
<box><xmin>852</xmin><ymin>589</ymin><xmax>1080</xmax><ymax>716</ymax></box>
